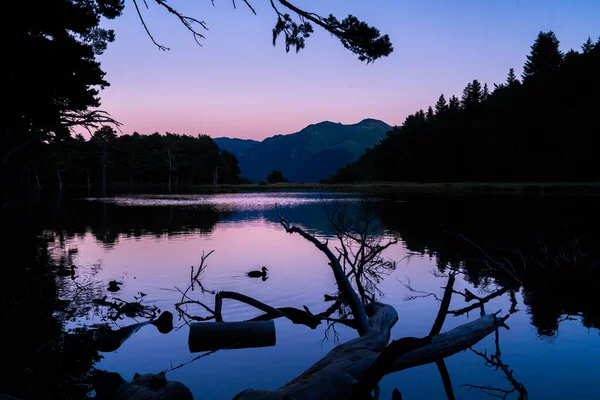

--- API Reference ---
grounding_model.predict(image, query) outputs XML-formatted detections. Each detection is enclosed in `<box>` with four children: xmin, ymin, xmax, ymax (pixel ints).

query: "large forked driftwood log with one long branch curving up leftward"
<box><xmin>230</xmin><ymin>211</ymin><xmax>508</xmax><ymax>400</ymax></box>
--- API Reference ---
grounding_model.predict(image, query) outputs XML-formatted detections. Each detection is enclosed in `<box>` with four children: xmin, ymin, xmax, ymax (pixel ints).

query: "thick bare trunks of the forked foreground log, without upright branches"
<box><xmin>235</xmin><ymin>303</ymin><xmax>505</xmax><ymax>400</ymax></box>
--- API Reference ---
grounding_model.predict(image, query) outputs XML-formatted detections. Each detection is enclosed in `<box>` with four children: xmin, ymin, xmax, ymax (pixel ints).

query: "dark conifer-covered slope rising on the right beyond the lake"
<box><xmin>331</xmin><ymin>32</ymin><xmax>600</xmax><ymax>182</ymax></box>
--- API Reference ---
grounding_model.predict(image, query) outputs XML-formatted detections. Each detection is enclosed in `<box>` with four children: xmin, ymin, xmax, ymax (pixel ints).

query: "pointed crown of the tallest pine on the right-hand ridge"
<box><xmin>523</xmin><ymin>31</ymin><xmax>564</xmax><ymax>80</ymax></box>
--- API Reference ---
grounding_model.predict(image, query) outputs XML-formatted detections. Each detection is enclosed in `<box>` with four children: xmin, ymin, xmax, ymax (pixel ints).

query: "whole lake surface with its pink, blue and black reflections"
<box><xmin>2</xmin><ymin>193</ymin><xmax>600</xmax><ymax>399</ymax></box>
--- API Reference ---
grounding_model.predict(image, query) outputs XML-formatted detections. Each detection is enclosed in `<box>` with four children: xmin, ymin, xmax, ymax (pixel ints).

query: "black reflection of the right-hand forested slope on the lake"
<box><xmin>378</xmin><ymin>196</ymin><xmax>600</xmax><ymax>335</ymax></box>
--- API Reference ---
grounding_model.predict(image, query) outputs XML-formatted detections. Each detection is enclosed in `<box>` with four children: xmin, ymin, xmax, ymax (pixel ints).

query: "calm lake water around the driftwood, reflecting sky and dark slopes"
<box><xmin>4</xmin><ymin>192</ymin><xmax>600</xmax><ymax>399</ymax></box>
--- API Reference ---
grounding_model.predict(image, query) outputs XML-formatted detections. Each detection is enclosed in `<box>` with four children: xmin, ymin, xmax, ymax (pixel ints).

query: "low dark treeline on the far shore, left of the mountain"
<box><xmin>7</xmin><ymin>126</ymin><xmax>240</xmax><ymax>191</ymax></box>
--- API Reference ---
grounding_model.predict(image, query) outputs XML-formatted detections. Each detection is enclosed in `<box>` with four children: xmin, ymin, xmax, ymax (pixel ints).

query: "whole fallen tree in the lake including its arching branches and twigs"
<box><xmin>175</xmin><ymin>208</ymin><xmax>508</xmax><ymax>399</ymax></box>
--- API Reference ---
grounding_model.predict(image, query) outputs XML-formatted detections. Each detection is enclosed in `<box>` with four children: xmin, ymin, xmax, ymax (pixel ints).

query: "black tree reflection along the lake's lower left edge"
<box><xmin>0</xmin><ymin>219</ymin><xmax>99</xmax><ymax>399</ymax></box>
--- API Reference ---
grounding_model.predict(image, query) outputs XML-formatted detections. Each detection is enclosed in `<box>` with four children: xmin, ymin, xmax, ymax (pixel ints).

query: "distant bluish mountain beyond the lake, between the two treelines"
<box><xmin>214</xmin><ymin>119</ymin><xmax>391</xmax><ymax>182</ymax></box>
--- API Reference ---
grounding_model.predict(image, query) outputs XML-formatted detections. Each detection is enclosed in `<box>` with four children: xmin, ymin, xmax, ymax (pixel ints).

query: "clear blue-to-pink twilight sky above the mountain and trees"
<box><xmin>99</xmin><ymin>0</ymin><xmax>600</xmax><ymax>140</ymax></box>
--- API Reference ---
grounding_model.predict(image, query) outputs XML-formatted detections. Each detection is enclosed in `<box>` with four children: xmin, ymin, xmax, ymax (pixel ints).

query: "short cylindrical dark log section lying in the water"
<box><xmin>188</xmin><ymin>321</ymin><xmax>276</xmax><ymax>353</ymax></box>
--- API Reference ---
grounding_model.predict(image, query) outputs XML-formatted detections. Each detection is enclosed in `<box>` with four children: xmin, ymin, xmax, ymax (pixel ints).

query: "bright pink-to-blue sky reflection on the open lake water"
<box><xmin>54</xmin><ymin>193</ymin><xmax>600</xmax><ymax>399</ymax></box>
